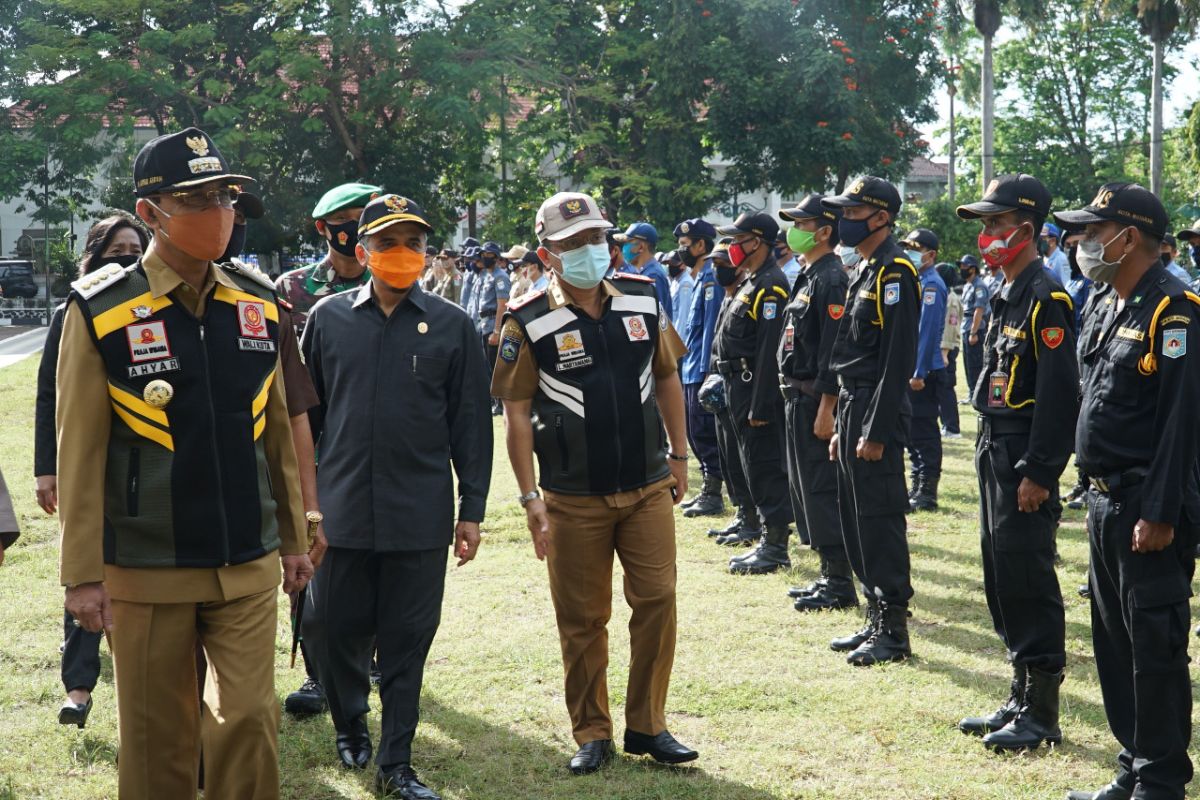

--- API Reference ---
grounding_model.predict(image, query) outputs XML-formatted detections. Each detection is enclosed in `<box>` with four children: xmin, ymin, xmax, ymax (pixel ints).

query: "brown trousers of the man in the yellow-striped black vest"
<box><xmin>112</xmin><ymin>588</ymin><xmax>280</xmax><ymax>800</ymax></box>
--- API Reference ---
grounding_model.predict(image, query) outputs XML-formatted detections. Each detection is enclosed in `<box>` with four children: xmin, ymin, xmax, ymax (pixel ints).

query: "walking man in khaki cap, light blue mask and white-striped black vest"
<box><xmin>492</xmin><ymin>192</ymin><xmax>697</xmax><ymax>775</ymax></box>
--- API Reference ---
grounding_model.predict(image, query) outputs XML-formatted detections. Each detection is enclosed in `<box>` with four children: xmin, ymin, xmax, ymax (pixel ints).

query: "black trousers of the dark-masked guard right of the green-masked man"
<box><xmin>838</xmin><ymin>386</ymin><xmax>912</xmax><ymax>606</ymax></box>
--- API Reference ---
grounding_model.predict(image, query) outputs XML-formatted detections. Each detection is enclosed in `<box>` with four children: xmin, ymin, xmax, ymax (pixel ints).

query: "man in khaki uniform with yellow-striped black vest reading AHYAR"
<box><xmin>58</xmin><ymin>128</ymin><xmax>312</xmax><ymax>800</ymax></box>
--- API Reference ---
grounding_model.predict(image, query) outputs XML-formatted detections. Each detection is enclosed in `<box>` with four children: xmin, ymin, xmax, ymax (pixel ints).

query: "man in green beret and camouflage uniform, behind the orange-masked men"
<box><xmin>275</xmin><ymin>184</ymin><xmax>383</xmax><ymax>335</ymax></box>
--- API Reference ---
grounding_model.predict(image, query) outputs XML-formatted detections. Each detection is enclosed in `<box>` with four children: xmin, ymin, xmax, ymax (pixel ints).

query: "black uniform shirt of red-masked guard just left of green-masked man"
<box><xmin>713</xmin><ymin>255</ymin><xmax>787</xmax><ymax>421</ymax></box>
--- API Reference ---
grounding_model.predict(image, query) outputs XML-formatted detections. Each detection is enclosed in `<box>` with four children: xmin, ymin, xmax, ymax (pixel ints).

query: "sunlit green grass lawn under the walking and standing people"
<box><xmin>0</xmin><ymin>357</ymin><xmax>1185</xmax><ymax>800</ymax></box>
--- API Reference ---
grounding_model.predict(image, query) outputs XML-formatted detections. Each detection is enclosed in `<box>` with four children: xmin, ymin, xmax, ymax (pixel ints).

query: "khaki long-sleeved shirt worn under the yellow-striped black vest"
<box><xmin>58</xmin><ymin>243</ymin><xmax>308</xmax><ymax>603</ymax></box>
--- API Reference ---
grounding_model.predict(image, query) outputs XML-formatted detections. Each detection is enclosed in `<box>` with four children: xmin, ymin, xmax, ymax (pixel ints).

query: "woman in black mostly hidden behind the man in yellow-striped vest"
<box><xmin>34</xmin><ymin>213</ymin><xmax>149</xmax><ymax>728</ymax></box>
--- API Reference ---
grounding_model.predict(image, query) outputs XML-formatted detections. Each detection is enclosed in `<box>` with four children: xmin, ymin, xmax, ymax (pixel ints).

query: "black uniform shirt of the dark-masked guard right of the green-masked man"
<box><xmin>829</xmin><ymin>236</ymin><xmax>920</xmax><ymax>444</ymax></box>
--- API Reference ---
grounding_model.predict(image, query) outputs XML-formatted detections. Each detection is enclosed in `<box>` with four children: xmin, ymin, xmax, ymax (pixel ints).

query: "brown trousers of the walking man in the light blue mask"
<box><xmin>546</xmin><ymin>479</ymin><xmax>676</xmax><ymax>745</ymax></box>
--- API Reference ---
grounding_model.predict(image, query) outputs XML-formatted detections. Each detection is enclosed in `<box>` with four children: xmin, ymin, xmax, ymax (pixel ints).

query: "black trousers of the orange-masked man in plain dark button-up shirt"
<box><xmin>302</xmin><ymin>547</ymin><xmax>446</xmax><ymax>766</ymax></box>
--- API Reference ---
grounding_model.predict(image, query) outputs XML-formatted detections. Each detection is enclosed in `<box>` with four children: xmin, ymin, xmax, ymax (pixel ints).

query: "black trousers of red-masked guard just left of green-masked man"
<box><xmin>725</xmin><ymin>375</ymin><xmax>793</xmax><ymax>525</ymax></box>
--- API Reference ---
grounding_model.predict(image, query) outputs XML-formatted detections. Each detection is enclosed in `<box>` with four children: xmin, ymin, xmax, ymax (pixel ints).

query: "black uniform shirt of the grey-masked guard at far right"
<box><xmin>1075</xmin><ymin>263</ymin><xmax>1200</xmax><ymax>524</ymax></box>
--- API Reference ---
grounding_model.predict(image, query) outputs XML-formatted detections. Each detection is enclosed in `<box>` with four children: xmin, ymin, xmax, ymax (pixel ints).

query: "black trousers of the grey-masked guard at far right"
<box><xmin>1087</xmin><ymin>486</ymin><xmax>1196</xmax><ymax>800</ymax></box>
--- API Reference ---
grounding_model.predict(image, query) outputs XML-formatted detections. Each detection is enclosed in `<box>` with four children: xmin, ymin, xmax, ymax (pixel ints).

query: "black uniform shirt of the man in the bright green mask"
<box><xmin>778</xmin><ymin>253</ymin><xmax>850</xmax><ymax>395</ymax></box>
